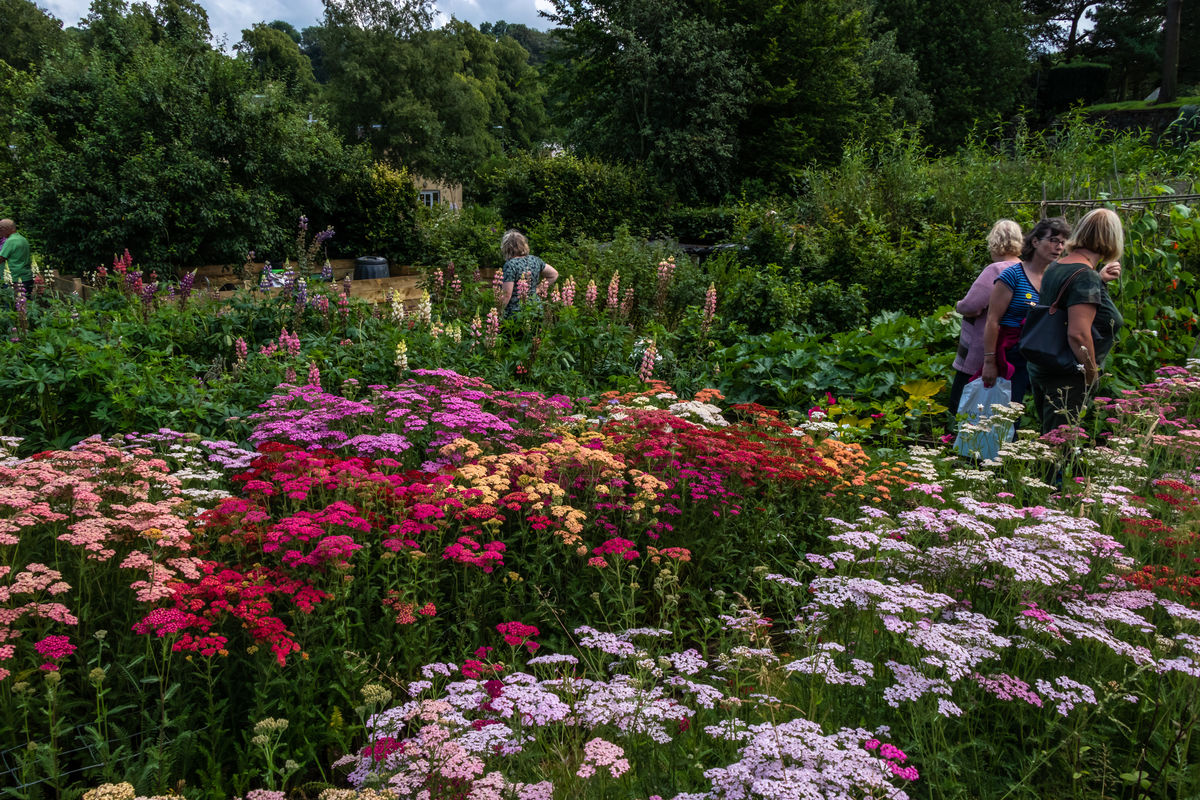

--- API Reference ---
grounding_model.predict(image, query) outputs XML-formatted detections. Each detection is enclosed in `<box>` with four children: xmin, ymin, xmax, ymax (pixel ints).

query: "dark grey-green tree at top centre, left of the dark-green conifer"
<box><xmin>550</xmin><ymin>0</ymin><xmax>749</xmax><ymax>198</ymax></box>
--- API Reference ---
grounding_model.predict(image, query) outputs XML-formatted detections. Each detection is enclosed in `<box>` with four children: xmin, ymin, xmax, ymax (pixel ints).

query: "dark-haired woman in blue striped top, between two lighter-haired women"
<box><xmin>980</xmin><ymin>217</ymin><xmax>1070</xmax><ymax>403</ymax></box>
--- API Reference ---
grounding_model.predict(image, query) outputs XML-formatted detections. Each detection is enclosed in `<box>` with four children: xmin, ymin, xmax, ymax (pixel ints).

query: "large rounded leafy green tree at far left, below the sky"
<box><xmin>14</xmin><ymin>0</ymin><xmax>366</xmax><ymax>273</ymax></box>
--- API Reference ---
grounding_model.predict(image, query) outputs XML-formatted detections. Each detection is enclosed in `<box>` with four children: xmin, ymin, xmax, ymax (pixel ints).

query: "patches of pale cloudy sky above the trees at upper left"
<box><xmin>35</xmin><ymin>0</ymin><xmax>551</xmax><ymax>47</ymax></box>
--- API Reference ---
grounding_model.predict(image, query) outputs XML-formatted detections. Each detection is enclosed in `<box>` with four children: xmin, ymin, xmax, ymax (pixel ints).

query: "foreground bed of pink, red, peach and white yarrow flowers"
<box><xmin>0</xmin><ymin>369</ymin><xmax>1200</xmax><ymax>800</ymax></box>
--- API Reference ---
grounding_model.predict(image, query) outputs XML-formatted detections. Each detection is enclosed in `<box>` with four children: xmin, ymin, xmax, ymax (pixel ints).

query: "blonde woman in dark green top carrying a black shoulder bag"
<box><xmin>1030</xmin><ymin>209</ymin><xmax>1124</xmax><ymax>434</ymax></box>
